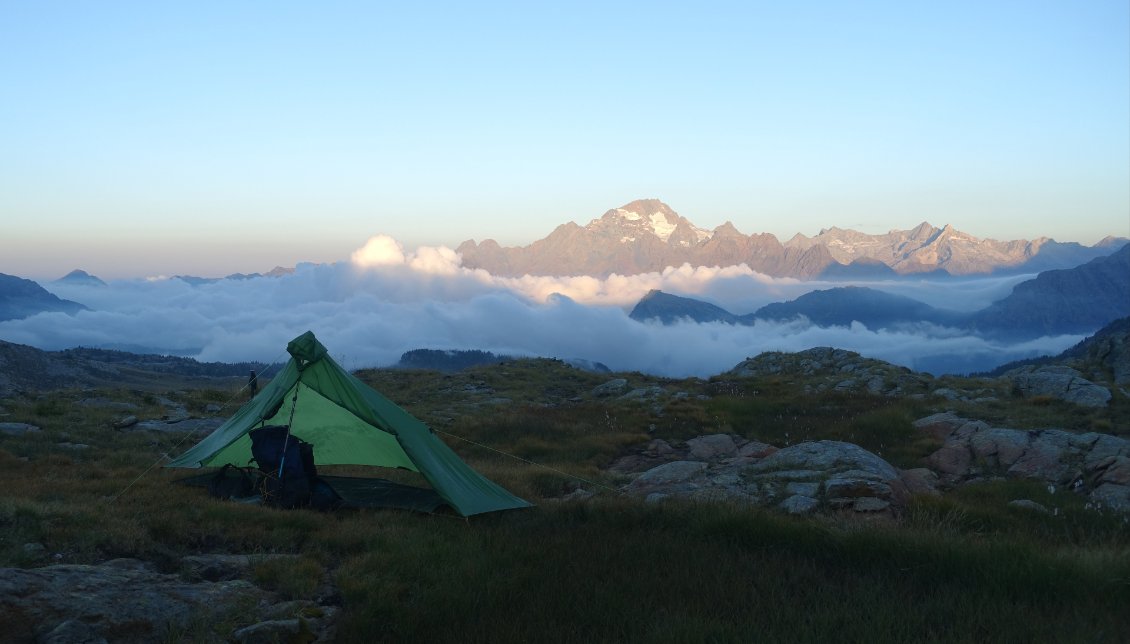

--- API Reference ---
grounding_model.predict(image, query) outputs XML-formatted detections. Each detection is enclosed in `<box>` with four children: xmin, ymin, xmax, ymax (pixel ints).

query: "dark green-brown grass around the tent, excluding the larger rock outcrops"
<box><xmin>0</xmin><ymin>360</ymin><xmax>1130</xmax><ymax>643</ymax></box>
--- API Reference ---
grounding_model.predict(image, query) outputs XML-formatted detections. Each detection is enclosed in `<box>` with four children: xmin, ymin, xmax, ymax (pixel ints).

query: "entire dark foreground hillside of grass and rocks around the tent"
<box><xmin>0</xmin><ymin>338</ymin><xmax>1130</xmax><ymax>643</ymax></box>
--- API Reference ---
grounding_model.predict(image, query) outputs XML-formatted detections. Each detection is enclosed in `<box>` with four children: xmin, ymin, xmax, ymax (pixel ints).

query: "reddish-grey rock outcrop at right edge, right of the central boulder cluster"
<box><xmin>914</xmin><ymin>412</ymin><xmax>1130</xmax><ymax>512</ymax></box>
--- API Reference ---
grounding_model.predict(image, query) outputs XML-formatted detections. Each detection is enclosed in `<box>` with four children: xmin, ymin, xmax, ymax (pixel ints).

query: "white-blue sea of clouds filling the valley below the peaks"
<box><xmin>0</xmin><ymin>235</ymin><xmax>1083</xmax><ymax>377</ymax></box>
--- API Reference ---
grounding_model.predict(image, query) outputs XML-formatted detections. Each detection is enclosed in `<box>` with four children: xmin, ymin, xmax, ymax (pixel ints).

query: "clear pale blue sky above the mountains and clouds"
<box><xmin>0</xmin><ymin>0</ymin><xmax>1130</xmax><ymax>278</ymax></box>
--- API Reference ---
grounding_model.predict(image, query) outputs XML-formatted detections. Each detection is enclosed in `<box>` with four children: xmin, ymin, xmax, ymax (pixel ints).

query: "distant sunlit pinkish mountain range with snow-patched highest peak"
<box><xmin>457</xmin><ymin>199</ymin><xmax>1127</xmax><ymax>279</ymax></box>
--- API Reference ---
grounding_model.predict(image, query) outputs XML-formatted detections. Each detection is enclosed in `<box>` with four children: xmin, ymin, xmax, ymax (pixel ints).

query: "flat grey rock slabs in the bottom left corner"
<box><xmin>0</xmin><ymin>556</ymin><xmax>338</xmax><ymax>643</ymax></box>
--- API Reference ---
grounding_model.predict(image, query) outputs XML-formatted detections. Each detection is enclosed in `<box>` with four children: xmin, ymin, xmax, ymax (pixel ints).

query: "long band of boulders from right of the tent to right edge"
<box><xmin>608</xmin><ymin>412</ymin><xmax>1130</xmax><ymax>514</ymax></box>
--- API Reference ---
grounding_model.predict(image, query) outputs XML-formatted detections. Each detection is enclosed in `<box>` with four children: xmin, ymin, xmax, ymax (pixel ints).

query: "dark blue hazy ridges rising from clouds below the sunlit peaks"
<box><xmin>629</xmin><ymin>245</ymin><xmax>1130</xmax><ymax>339</ymax></box>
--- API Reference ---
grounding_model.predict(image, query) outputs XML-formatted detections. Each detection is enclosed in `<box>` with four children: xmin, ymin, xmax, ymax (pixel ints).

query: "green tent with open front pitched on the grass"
<box><xmin>165</xmin><ymin>331</ymin><xmax>530</xmax><ymax>516</ymax></box>
